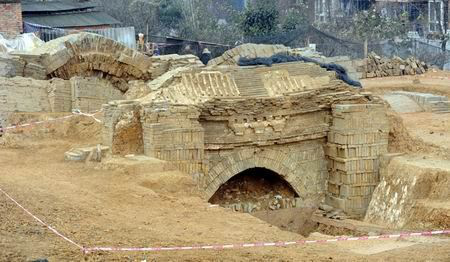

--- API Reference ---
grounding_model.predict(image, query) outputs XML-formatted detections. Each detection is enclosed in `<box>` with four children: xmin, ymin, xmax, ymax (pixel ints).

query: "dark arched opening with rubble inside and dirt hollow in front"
<box><xmin>209</xmin><ymin>168</ymin><xmax>317</xmax><ymax>236</ymax></box>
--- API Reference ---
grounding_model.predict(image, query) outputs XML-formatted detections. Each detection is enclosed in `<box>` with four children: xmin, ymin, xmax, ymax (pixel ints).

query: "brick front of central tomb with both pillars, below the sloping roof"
<box><xmin>104</xmin><ymin>100</ymin><xmax>389</xmax><ymax>217</ymax></box>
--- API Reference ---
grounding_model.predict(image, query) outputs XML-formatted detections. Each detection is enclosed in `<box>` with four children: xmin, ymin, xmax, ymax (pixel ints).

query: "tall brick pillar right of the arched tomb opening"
<box><xmin>327</xmin><ymin>104</ymin><xmax>389</xmax><ymax>216</ymax></box>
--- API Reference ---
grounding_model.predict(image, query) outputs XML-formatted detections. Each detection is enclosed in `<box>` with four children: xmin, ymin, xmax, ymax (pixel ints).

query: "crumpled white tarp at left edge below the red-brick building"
<box><xmin>0</xmin><ymin>33</ymin><xmax>44</xmax><ymax>53</ymax></box>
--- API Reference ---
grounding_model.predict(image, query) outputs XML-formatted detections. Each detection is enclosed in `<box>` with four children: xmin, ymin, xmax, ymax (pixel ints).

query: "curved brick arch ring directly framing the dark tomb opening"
<box><xmin>205</xmin><ymin>149</ymin><xmax>308</xmax><ymax>198</ymax></box>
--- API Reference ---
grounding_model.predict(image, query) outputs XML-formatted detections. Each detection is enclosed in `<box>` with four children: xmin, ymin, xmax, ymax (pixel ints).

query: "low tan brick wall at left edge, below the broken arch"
<box><xmin>0</xmin><ymin>77</ymin><xmax>123</xmax><ymax>126</ymax></box>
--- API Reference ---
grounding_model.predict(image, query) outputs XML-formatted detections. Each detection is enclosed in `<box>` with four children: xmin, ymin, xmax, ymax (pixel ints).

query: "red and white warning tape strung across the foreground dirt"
<box><xmin>0</xmin><ymin>188</ymin><xmax>450</xmax><ymax>254</ymax></box>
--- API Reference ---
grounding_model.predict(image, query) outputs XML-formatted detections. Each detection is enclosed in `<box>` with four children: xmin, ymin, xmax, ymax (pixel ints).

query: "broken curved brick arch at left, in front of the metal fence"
<box><xmin>36</xmin><ymin>33</ymin><xmax>152</xmax><ymax>81</ymax></box>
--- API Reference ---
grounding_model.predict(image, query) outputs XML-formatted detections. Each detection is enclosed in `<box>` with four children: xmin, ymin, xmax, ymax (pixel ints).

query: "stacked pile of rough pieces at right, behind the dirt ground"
<box><xmin>366</xmin><ymin>53</ymin><xmax>428</xmax><ymax>78</ymax></box>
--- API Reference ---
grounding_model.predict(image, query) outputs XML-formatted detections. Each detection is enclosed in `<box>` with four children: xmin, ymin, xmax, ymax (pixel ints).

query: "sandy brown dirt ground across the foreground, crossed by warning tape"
<box><xmin>0</xmin><ymin>114</ymin><xmax>450</xmax><ymax>261</ymax></box>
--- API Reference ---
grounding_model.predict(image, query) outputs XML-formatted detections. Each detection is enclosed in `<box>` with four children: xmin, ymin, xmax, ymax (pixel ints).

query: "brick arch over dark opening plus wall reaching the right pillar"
<box><xmin>204</xmin><ymin>146</ymin><xmax>326</xmax><ymax>198</ymax></box>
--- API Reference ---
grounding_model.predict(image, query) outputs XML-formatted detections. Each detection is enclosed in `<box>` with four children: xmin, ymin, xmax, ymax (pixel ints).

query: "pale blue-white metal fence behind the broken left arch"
<box><xmin>24</xmin><ymin>23</ymin><xmax>136</xmax><ymax>49</ymax></box>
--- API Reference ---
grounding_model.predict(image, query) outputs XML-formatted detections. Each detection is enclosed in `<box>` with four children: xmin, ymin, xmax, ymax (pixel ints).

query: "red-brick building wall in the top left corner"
<box><xmin>0</xmin><ymin>0</ymin><xmax>23</xmax><ymax>37</ymax></box>
